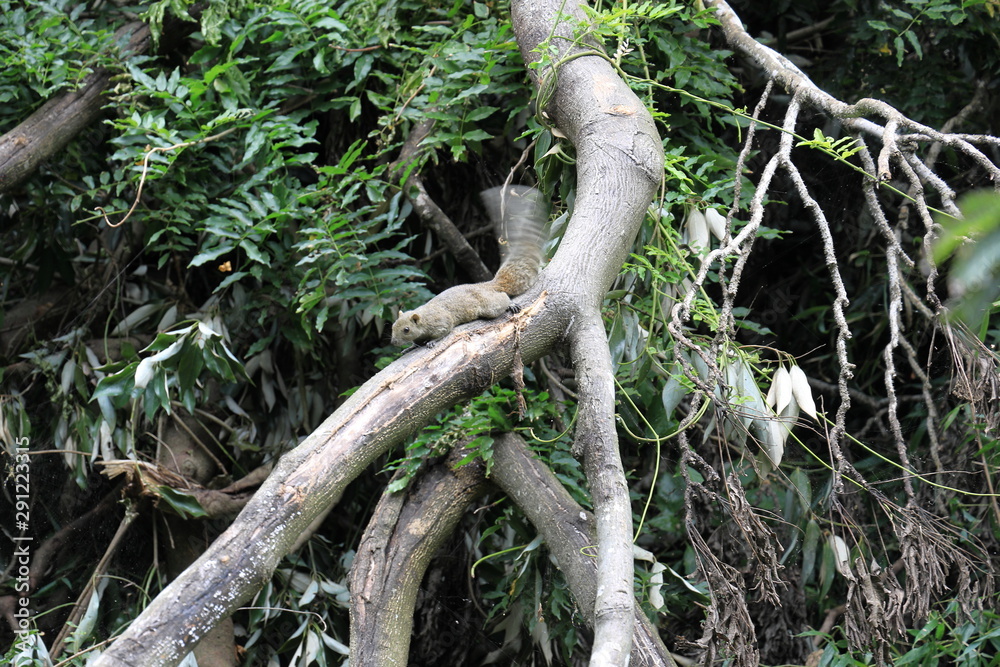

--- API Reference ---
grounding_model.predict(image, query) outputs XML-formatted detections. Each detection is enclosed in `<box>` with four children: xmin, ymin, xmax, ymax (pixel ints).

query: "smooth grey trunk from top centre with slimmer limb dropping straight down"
<box><xmin>511</xmin><ymin>0</ymin><xmax>663</xmax><ymax>665</ymax></box>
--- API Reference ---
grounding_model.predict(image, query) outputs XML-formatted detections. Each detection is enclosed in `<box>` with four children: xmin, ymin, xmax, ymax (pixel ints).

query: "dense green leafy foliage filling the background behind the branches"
<box><xmin>0</xmin><ymin>0</ymin><xmax>1000</xmax><ymax>666</ymax></box>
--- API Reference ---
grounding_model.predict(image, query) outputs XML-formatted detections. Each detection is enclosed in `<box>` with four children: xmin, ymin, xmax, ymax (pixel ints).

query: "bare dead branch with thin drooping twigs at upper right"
<box><xmin>668</xmin><ymin>5</ymin><xmax>1000</xmax><ymax>664</ymax></box>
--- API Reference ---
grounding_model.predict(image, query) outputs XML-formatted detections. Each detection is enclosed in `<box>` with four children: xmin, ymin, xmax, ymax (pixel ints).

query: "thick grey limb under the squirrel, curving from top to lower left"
<box><xmin>90</xmin><ymin>1</ymin><xmax>663</xmax><ymax>667</ymax></box>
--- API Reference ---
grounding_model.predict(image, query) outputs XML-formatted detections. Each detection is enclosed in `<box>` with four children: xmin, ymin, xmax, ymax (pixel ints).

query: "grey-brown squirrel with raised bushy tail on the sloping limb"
<box><xmin>392</xmin><ymin>185</ymin><xmax>548</xmax><ymax>345</ymax></box>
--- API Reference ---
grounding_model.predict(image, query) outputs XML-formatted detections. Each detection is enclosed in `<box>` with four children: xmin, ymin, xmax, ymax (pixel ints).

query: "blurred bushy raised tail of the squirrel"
<box><xmin>480</xmin><ymin>185</ymin><xmax>549</xmax><ymax>296</ymax></box>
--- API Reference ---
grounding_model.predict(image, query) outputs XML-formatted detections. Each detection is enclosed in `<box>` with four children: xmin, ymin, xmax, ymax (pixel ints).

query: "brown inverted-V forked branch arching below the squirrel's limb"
<box><xmin>351</xmin><ymin>433</ymin><xmax>676</xmax><ymax>667</ymax></box>
